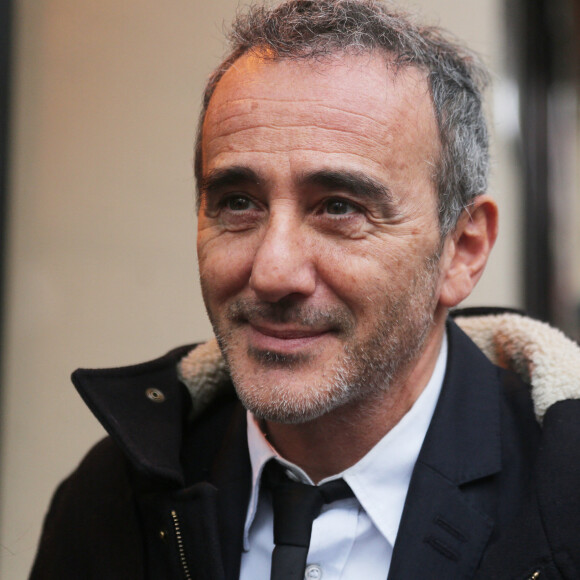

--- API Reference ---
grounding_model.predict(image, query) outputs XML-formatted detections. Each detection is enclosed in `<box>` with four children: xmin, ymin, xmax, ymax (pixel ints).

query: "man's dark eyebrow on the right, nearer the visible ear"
<box><xmin>298</xmin><ymin>169</ymin><xmax>395</xmax><ymax>205</ymax></box>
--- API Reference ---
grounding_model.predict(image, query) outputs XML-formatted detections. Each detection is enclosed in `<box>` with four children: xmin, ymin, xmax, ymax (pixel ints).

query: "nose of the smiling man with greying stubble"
<box><xmin>249</xmin><ymin>216</ymin><xmax>316</xmax><ymax>302</ymax></box>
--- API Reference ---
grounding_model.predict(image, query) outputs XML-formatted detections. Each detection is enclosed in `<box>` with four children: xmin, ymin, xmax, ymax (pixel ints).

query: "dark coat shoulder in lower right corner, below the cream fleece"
<box><xmin>477</xmin><ymin>400</ymin><xmax>580</xmax><ymax>580</ymax></box>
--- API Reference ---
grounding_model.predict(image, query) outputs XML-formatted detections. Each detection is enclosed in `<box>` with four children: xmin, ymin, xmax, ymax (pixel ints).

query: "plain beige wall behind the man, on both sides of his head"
<box><xmin>0</xmin><ymin>0</ymin><xmax>519</xmax><ymax>580</ymax></box>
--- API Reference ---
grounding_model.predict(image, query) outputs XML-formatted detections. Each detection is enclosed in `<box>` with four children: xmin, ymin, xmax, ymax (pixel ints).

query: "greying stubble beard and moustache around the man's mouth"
<box><xmin>204</xmin><ymin>253</ymin><xmax>439</xmax><ymax>424</ymax></box>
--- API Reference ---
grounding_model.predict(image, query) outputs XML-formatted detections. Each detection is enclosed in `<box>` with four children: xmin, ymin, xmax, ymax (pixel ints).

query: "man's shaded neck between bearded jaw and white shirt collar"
<box><xmin>262</xmin><ymin>326</ymin><xmax>444</xmax><ymax>483</ymax></box>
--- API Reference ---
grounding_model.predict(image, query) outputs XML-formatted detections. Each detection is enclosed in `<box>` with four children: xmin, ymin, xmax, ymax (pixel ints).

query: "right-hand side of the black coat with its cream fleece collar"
<box><xmin>454</xmin><ymin>309</ymin><xmax>580</xmax><ymax>579</ymax></box>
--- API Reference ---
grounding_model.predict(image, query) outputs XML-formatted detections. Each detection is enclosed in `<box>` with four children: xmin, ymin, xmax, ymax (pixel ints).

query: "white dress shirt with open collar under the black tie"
<box><xmin>240</xmin><ymin>336</ymin><xmax>447</xmax><ymax>580</ymax></box>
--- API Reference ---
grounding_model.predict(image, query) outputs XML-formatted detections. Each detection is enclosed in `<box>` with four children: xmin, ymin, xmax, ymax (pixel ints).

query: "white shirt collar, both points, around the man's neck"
<box><xmin>244</xmin><ymin>334</ymin><xmax>447</xmax><ymax>551</ymax></box>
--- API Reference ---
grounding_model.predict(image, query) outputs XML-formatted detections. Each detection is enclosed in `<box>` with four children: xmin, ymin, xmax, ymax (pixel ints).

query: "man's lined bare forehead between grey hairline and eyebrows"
<box><xmin>202</xmin><ymin>54</ymin><xmax>439</xmax><ymax>193</ymax></box>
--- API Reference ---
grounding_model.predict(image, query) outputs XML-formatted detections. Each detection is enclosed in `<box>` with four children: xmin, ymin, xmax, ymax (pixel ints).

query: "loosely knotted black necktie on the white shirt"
<box><xmin>262</xmin><ymin>460</ymin><xmax>353</xmax><ymax>580</ymax></box>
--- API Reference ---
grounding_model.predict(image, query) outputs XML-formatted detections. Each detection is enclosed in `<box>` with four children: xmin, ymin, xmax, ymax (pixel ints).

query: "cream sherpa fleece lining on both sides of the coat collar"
<box><xmin>179</xmin><ymin>312</ymin><xmax>580</xmax><ymax>422</ymax></box>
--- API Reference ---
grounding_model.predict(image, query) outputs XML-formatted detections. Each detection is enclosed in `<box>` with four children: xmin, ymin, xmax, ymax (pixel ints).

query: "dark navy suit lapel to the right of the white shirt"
<box><xmin>389</xmin><ymin>322</ymin><xmax>501</xmax><ymax>580</ymax></box>
